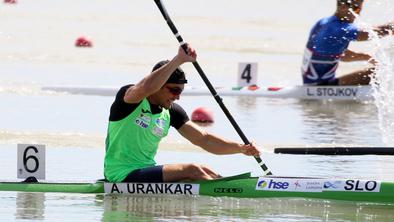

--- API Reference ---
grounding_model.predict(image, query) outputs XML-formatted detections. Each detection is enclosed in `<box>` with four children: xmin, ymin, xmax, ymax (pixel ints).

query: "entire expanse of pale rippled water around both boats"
<box><xmin>0</xmin><ymin>0</ymin><xmax>394</xmax><ymax>221</ymax></box>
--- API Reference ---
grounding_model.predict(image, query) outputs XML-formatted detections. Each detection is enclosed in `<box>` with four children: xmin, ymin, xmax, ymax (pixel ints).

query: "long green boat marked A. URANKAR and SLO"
<box><xmin>0</xmin><ymin>173</ymin><xmax>394</xmax><ymax>204</ymax></box>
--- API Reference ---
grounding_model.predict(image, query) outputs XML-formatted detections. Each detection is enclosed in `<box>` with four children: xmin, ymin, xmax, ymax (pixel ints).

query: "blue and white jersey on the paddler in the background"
<box><xmin>301</xmin><ymin>16</ymin><xmax>358</xmax><ymax>84</ymax></box>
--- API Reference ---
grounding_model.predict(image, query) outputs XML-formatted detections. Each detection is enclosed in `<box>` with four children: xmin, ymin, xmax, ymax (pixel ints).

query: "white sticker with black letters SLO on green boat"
<box><xmin>324</xmin><ymin>180</ymin><xmax>381</xmax><ymax>192</ymax></box>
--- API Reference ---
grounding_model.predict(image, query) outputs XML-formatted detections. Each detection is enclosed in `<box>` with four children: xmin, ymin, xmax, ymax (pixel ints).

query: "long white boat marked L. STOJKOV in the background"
<box><xmin>41</xmin><ymin>85</ymin><xmax>373</xmax><ymax>101</ymax></box>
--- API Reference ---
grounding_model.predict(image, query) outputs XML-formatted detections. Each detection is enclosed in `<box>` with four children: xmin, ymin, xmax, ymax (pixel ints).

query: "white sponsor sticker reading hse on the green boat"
<box><xmin>256</xmin><ymin>177</ymin><xmax>323</xmax><ymax>192</ymax></box>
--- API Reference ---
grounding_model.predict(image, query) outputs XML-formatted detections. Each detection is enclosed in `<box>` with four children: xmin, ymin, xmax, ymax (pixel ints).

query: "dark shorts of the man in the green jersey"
<box><xmin>123</xmin><ymin>165</ymin><xmax>163</xmax><ymax>183</ymax></box>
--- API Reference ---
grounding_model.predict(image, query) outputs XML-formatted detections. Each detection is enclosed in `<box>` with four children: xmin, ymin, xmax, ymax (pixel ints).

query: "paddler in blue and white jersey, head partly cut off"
<box><xmin>301</xmin><ymin>0</ymin><xmax>394</xmax><ymax>85</ymax></box>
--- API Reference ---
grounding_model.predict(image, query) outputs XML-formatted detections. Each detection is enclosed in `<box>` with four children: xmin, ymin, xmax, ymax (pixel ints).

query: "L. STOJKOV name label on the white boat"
<box><xmin>306</xmin><ymin>87</ymin><xmax>358</xmax><ymax>97</ymax></box>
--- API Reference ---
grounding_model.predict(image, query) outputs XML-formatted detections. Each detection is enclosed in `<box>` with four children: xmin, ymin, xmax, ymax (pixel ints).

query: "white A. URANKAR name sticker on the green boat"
<box><xmin>104</xmin><ymin>183</ymin><xmax>200</xmax><ymax>195</ymax></box>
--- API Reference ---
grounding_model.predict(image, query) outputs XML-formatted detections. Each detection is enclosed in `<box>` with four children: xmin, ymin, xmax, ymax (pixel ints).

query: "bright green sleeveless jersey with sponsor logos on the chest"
<box><xmin>104</xmin><ymin>98</ymin><xmax>170</xmax><ymax>182</ymax></box>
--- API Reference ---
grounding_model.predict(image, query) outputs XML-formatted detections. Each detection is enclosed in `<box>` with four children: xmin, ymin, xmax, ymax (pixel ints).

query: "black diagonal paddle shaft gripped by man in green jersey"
<box><xmin>155</xmin><ymin>0</ymin><xmax>272</xmax><ymax>175</ymax></box>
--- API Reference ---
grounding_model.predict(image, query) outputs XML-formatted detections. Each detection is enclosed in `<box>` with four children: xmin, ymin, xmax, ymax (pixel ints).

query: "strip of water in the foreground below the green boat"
<box><xmin>0</xmin><ymin>193</ymin><xmax>392</xmax><ymax>221</ymax></box>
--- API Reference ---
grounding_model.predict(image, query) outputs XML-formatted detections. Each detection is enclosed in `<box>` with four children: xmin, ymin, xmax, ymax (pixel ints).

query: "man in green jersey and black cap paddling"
<box><xmin>104</xmin><ymin>45</ymin><xmax>260</xmax><ymax>182</ymax></box>
